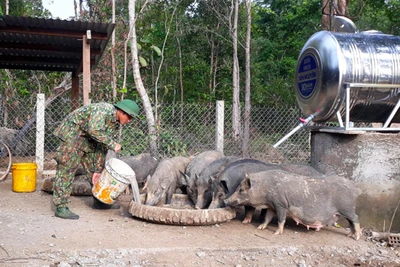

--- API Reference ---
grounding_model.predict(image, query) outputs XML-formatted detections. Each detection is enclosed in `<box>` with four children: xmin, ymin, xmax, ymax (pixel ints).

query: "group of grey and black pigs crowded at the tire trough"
<box><xmin>120</xmin><ymin>150</ymin><xmax>361</xmax><ymax>240</ymax></box>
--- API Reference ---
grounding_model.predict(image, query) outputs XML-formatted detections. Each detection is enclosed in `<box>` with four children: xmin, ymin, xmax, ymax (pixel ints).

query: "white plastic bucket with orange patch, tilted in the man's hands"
<box><xmin>92</xmin><ymin>158</ymin><xmax>136</xmax><ymax>205</ymax></box>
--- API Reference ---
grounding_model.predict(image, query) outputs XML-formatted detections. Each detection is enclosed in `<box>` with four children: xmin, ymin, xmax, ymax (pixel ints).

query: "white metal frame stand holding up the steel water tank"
<box><xmin>336</xmin><ymin>83</ymin><xmax>400</xmax><ymax>132</ymax></box>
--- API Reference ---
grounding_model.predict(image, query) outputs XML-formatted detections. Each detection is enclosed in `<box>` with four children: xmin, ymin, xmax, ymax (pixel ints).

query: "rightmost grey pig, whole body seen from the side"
<box><xmin>225</xmin><ymin>170</ymin><xmax>361</xmax><ymax>240</ymax></box>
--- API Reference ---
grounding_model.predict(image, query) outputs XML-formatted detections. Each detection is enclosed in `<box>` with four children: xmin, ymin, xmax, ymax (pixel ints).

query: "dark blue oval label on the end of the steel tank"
<box><xmin>297</xmin><ymin>53</ymin><xmax>317</xmax><ymax>98</ymax></box>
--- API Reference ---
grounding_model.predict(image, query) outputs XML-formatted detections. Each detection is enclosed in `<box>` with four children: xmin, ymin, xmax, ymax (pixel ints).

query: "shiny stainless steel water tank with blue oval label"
<box><xmin>295</xmin><ymin>31</ymin><xmax>400</xmax><ymax>122</ymax></box>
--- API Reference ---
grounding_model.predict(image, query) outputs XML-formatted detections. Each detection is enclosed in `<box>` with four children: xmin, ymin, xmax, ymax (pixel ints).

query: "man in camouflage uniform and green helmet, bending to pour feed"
<box><xmin>53</xmin><ymin>99</ymin><xmax>139</xmax><ymax>219</ymax></box>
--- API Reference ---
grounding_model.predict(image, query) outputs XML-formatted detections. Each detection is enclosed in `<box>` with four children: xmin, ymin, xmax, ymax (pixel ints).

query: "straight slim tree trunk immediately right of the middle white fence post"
<box><xmin>231</xmin><ymin>0</ymin><xmax>240</xmax><ymax>141</ymax></box>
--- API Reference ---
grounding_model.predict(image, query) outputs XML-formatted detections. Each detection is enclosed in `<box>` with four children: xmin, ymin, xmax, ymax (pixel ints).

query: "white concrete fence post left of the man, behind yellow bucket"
<box><xmin>36</xmin><ymin>94</ymin><xmax>45</xmax><ymax>178</ymax></box>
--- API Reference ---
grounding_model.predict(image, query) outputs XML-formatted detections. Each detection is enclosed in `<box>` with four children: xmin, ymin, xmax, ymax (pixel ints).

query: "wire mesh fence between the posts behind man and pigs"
<box><xmin>0</xmin><ymin>96</ymin><xmax>310</xmax><ymax>170</ymax></box>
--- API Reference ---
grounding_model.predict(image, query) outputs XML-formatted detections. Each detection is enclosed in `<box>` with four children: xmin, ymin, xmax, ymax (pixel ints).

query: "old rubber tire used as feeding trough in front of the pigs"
<box><xmin>129</xmin><ymin>197</ymin><xmax>236</xmax><ymax>225</ymax></box>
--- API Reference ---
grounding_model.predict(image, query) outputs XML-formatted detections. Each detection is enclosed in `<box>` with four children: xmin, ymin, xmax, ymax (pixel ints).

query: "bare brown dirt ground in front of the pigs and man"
<box><xmin>0</xmin><ymin>178</ymin><xmax>400</xmax><ymax>267</ymax></box>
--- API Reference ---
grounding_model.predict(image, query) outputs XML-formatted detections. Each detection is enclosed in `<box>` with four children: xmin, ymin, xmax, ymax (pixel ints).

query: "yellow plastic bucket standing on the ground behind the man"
<box><xmin>11</xmin><ymin>162</ymin><xmax>37</xmax><ymax>192</ymax></box>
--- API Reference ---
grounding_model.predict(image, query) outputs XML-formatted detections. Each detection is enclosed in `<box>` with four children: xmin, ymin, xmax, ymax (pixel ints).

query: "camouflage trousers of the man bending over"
<box><xmin>53</xmin><ymin>142</ymin><xmax>107</xmax><ymax>207</ymax></box>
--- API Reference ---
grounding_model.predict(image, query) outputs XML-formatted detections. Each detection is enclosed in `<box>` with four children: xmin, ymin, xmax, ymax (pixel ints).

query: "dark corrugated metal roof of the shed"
<box><xmin>0</xmin><ymin>16</ymin><xmax>115</xmax><ymax>74</ymax></box>
